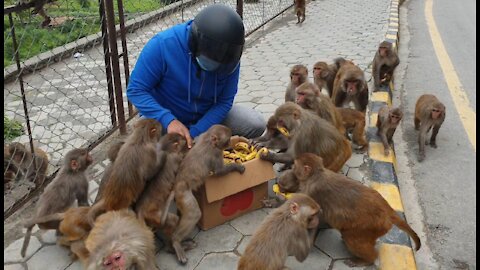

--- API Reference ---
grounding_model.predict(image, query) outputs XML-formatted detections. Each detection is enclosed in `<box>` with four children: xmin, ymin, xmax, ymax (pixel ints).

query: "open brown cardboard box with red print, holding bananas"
<box><xmin>195</xmin><ymin>159</ymin><xmax>275</xmax><ymax>230</ymax></box>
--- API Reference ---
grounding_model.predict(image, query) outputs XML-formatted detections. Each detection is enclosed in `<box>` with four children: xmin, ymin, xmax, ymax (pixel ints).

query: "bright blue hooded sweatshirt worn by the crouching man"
<box><xmin>127</xmin><ymin>20</ymin><xmax>240</xmax><ymax>137</ymax></box>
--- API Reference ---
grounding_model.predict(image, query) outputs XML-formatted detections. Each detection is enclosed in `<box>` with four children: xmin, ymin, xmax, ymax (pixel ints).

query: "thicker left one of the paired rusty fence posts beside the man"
<box><xmin>105</xmin><ymin>0</ymin><xmax>127</xmax><ymax>135</ymax></box>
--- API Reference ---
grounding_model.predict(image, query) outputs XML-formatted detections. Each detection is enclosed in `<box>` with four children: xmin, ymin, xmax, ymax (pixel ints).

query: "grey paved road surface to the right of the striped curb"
<box><xmin>394</xmin><ymin>0</ymin><xmax>476</xmax><ymax>269</ymax></box>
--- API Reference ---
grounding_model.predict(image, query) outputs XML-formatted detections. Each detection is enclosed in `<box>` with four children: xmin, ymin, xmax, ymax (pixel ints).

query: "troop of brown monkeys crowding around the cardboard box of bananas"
<box><xmin>5</xmin><ymin>39</ymin><xmax>445</xmax><ymax>270</ymax></box>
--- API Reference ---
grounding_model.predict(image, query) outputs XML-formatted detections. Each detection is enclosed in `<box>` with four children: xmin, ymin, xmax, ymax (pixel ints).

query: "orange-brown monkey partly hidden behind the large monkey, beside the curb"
<box><xmin>336</xmin><ymin>107</ymin><xmax>368</xmax><ymax>151</ymax></box>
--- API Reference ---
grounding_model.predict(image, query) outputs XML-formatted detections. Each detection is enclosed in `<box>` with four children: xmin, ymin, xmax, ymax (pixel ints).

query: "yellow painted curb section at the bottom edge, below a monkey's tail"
<box><xmin>379</xmin><ymin>243</ymin><xmax>417</xmax><ymax>270</ymax></box>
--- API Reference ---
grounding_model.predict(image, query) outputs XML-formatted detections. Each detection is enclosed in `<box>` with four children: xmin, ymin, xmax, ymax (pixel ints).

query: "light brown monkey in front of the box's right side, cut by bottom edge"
<box><xmin>237</xmin><ymin>194</ymin><xmax>321</xmax><ymax>270</ymax></box>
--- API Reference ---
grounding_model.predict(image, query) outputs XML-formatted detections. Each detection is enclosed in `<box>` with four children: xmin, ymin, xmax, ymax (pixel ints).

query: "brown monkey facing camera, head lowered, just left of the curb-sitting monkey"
<box><xmin>332</xmin><ymin>60</ymin><xmax>368</xmax><ymax>113</ymax></box>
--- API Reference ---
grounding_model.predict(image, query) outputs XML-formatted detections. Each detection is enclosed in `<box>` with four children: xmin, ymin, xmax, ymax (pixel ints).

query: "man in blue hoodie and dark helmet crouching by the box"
<box><xmin>127</xmin><ymin>4</ymin><xmax>266</xmax><ymax>147</ymax></box>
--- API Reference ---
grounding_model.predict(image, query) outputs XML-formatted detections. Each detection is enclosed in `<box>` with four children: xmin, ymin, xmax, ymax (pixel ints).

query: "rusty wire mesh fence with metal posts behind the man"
<box><xmin>4</xmin><ymin>0</ymin><xmax>293</xmax><ymax>219</ymax></box>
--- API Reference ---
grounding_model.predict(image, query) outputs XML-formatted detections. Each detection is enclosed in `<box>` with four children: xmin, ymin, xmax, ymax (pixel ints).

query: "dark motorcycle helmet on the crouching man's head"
<box><xmin>188</xmin><ymin>4</ymin><xmax>245</xmax><ymax>74</ymax></box>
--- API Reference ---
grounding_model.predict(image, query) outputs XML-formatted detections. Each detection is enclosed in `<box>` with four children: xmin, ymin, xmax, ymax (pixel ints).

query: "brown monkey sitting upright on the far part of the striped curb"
<box><xmin>372</xmin><ymin>41</ymin><xmax>400</xmax><ymax>91</ymax></box>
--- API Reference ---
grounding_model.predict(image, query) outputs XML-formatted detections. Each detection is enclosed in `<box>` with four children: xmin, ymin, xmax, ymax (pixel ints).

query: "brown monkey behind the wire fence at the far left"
<box><xmin>4</xmin><ymin>142</ymin><xmax>48</xmax><ymax>186</ymax></box>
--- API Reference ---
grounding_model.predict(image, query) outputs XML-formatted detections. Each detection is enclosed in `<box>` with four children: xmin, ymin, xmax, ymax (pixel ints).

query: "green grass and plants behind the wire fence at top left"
<box><xmin>3</xmin><ymin>0</ymin><xmax>165</xmax><ymax>67</ymax></box>
